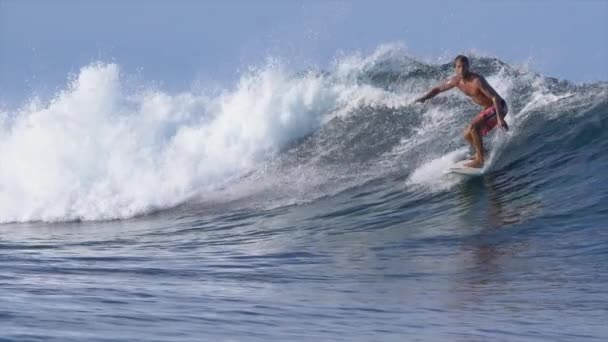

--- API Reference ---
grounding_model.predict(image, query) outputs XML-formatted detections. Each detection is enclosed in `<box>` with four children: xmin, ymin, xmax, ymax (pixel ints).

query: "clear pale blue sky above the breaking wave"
<box><xmin>0</xmin><ymin>0</ymin><xmax>608</xmax><ymax>103</ymax></box>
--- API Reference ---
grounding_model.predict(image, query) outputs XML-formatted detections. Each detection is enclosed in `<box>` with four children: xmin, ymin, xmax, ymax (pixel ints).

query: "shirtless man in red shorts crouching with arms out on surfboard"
<box><xmin>416</xmin><ymin>55</ymin><xmax>509</xmax><ymax>168</ymax></box>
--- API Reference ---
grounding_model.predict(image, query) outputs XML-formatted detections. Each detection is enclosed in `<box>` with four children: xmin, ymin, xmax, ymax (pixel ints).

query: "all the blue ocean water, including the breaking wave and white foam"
<box><xmin>0</xmin><ymin>47</ymin><xmax>608</xmax><ymax>341</ymax></box>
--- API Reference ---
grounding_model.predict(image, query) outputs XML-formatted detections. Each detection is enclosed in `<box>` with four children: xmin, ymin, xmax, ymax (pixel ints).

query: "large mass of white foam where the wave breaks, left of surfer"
<box><xmin>0</xmin><ymin>64</ymin><xmax>341</xmax><ymax>222</ymax></box>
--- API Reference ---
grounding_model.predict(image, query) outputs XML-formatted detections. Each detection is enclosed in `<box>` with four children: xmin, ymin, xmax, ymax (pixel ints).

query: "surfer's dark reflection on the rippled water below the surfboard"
<box><xmin>454</xmin><ymin>174</ymin><xmax>542</xmax><ymax>310</ymax></box>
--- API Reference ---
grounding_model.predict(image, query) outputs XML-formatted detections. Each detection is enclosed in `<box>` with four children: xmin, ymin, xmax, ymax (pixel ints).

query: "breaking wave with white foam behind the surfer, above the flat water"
<box><xmin>0</xmin><ymin>46</ymin><xmax>608</xmax><ymax>223</ymax></box>
